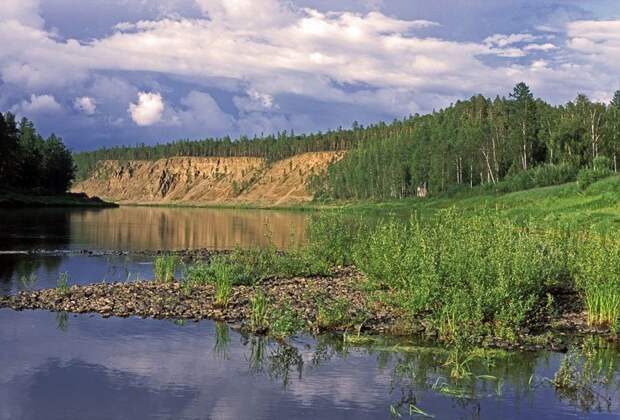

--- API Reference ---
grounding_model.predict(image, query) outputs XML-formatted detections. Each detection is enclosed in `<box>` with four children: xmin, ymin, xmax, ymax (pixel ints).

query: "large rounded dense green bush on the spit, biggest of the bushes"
<box><xmin>354</xmin><ymin>210</ymin><xmax>569</xmax><ymax>338</ymax></box>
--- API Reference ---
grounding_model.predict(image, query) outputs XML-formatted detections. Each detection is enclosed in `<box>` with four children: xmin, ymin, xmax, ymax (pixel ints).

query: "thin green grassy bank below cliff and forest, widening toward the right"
<box><xmin>78</xmin><ymin>176</ymin><xmax>620</xmax><ymax>231</ymax></box>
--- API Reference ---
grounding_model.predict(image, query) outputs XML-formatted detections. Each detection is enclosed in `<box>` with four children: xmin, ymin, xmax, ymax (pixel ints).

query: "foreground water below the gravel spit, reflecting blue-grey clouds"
<box><xmin>0</xmin><ymin>310</ymin><xmax>620</xmax><ymax>419</ymax></box>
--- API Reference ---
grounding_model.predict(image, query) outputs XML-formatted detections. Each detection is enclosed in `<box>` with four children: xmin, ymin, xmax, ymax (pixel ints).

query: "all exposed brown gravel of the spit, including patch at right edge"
<box><xmin>0</xmin><ymin>267</ymin><xmax>617</xmax><ymax>352</ymax></box>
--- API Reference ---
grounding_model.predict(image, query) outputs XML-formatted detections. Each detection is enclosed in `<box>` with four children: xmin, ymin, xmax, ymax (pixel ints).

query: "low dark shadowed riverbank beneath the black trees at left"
<box><xmin>0</xmin><ymin>191</ymin><xmax>118</xmax><ymax>208</ymax></box>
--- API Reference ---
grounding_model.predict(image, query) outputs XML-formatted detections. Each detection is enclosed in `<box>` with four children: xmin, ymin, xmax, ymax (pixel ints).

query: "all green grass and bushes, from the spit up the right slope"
<box><xmin>155</xmin><ymin>172</ymin><xmax>620</xmax><ymax>344</ymax></box>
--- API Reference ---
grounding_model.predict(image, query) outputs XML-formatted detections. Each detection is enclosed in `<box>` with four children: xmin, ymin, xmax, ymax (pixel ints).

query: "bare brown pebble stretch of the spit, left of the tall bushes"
<box><xmin>0</xmin><ymin>268</ymin><xmax>395</xmax><ymax>333</ymax></box>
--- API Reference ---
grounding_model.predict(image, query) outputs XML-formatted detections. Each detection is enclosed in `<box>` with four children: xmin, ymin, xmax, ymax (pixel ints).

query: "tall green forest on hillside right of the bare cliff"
<box><xmin>314</xmin><ymin>83</ymin><xmax>620</xmax><ymax>199</ymax></box>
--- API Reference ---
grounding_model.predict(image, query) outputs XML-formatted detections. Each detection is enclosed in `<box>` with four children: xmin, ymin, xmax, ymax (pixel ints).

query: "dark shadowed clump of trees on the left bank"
<box><xmin>0</xmin><ymin>112</ymin><xmax>75</xmax><ymax>194</ymax></box>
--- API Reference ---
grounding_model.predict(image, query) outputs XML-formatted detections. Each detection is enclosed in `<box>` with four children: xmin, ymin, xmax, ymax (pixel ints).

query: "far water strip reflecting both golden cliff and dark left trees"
<box><xmin>0</xmin><ymin>207</ymin><xmax>309</xmax><ymax>250</ymax></box>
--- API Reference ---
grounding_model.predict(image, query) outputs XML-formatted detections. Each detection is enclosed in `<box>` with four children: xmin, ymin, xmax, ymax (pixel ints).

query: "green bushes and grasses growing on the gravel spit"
<box><xmin>131</xmin><ymin>203</ymin><xmax>620</xmax><ymax>344</ymax></box>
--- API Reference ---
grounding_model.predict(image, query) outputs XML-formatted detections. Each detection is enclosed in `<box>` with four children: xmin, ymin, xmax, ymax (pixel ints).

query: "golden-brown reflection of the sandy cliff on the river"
<box><xmin>71</xmin><ymin>207</ymin><xmax>308</xmax><ymax>250</ymax></box>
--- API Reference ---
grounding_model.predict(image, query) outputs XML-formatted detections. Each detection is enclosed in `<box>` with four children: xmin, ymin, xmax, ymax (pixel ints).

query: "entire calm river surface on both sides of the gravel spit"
<box><xmin>0</xmin><ymin>208</ymin><xmax>620</xmax><ymax>420</ymax></box>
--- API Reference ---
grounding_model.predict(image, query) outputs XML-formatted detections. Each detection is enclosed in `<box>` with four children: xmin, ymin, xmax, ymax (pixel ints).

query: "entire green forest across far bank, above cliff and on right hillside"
<box><xmin>74</xmin><ymin>83</ymin><xmax>620</xmax><ymax>199</ymax></box>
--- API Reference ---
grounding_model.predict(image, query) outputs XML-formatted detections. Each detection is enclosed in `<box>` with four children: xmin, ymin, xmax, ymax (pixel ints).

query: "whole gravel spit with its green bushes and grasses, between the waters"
<box><xmin>0</xmin><ymin>203</ymin><xmax>620</xmax><ymax>350</ymax></box>
